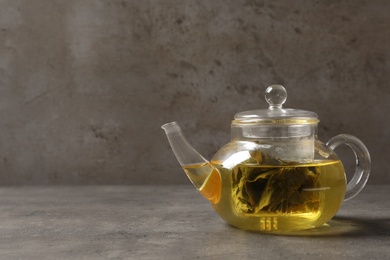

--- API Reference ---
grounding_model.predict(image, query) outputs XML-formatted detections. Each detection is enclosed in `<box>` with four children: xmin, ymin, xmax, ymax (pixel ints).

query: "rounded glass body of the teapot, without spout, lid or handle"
<box><xmin>211</xmin><ymin>135</ymin><xmax>346</xmax><ymax>233</ymax></box>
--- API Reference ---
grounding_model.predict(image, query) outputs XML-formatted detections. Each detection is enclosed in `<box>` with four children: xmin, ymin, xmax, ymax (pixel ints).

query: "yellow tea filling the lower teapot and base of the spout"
<box><xmin>183</xmin><ymin>160</ymin><xmax>346</xmax><ymax>233</ymax></box>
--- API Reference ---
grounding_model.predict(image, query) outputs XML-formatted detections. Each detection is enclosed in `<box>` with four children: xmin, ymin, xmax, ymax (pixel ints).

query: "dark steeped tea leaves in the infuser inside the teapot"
<box><xmin>233</xmin><ymin>151</ymin><xmax>320</xmax><ymax>214</ymax></box>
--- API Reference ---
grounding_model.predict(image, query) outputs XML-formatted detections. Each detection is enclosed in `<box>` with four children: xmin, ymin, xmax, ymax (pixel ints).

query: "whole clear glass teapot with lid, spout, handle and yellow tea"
<box><xmin>162</xmin><ymin>85</ymin><xmax>371</xmax><ymax>233</ymax></box>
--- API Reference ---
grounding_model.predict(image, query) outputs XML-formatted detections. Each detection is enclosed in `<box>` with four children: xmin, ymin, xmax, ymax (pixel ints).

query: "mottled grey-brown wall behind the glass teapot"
<box><xmin>0</xmin><ymin>0</ymin><xmax>390</xmax><ymax>185</ymax></box>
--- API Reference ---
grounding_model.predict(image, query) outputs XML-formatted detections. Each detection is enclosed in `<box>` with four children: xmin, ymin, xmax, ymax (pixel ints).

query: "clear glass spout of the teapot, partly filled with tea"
<box><xmin>161</xmin><ymin>122</ymin><xmax>222</xmax><ymax>203</ymax></box>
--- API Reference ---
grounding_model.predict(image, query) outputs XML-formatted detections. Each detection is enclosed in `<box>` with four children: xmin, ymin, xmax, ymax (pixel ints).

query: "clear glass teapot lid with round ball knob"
<box><xmin>232</xmin><ymin>85</ymin><xmax>319</xmax><ymax>125</ymax></box>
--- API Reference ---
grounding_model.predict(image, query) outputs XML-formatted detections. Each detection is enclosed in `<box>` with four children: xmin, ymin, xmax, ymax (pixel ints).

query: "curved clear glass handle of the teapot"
<box><xmin>326</xmin><ymin>134</ymin><xmax>371</xmax><ymax>200</ymax></box>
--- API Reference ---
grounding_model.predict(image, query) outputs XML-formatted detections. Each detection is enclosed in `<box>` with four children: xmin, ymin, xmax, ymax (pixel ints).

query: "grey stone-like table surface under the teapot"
<box><xmin>0</xmin><ymin>186</ymin><xmax>390</xmax><ymax>259</ymax></box>
